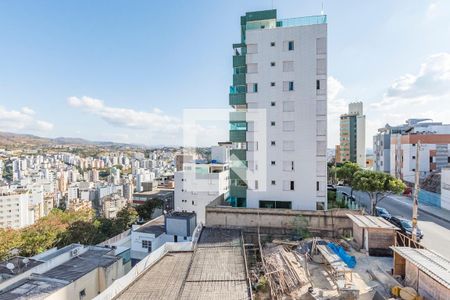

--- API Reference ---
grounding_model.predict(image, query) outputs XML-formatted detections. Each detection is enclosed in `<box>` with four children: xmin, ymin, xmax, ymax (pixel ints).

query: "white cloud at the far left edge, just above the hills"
<box><xmin>0</xmin><ymin>106</ymin><xmax>53</xmax><ymax>132</ymax></box>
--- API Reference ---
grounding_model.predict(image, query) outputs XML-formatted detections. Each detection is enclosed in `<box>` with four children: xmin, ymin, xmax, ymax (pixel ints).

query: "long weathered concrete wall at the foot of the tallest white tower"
<box><xmin>206</xmin><ymin>207</ymin><xmax>359</xmax><ymax>236</ymax></box>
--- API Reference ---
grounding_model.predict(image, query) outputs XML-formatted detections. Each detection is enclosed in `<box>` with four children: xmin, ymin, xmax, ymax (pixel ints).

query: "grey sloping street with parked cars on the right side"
<box><xmin>337</xmin><ymin>186</ymin><xmax>450</xmax><ymax>259</ymax></box>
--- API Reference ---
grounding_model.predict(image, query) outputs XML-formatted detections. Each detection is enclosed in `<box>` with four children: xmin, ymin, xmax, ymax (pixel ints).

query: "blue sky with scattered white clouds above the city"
<box><xmin>0</xmin><ymin>0</ymin><xmax>450</xmax><ymax>148</ymax></box>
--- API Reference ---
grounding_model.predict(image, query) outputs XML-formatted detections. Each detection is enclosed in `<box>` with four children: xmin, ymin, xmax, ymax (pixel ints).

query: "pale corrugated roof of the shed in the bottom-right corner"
<box><xmin>391</xmin><ymin>247</ymin><xmax>450</xmax><ymax>289</ymax></box>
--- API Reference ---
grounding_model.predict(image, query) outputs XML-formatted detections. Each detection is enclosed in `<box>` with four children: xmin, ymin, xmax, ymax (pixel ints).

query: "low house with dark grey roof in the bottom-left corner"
<box><xmin>0</xmin><ymin>244</ymin><xmax>124</xmax><ymax>300</ymax></box>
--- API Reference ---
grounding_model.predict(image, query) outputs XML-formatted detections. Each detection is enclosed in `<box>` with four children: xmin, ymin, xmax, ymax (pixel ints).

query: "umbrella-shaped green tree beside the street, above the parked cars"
<box><xmin>352</xmin><ymin>170</ymin><xmax>406</xmax><ymax>215</ymax></box>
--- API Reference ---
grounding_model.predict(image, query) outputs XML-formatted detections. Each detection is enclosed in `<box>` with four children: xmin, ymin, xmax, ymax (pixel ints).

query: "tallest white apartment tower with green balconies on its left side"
<box><xmin>229</xmin><ymin>10</ymin><xmax>327</xmax><ymax>210</ymax></box>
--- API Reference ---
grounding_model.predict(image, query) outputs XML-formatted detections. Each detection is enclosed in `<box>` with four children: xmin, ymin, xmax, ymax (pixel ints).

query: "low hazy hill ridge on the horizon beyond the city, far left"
<box><xmin>0</xmin><ymin>132</ymin><xmax>145</xmax><ymax>148</ymax></box>
